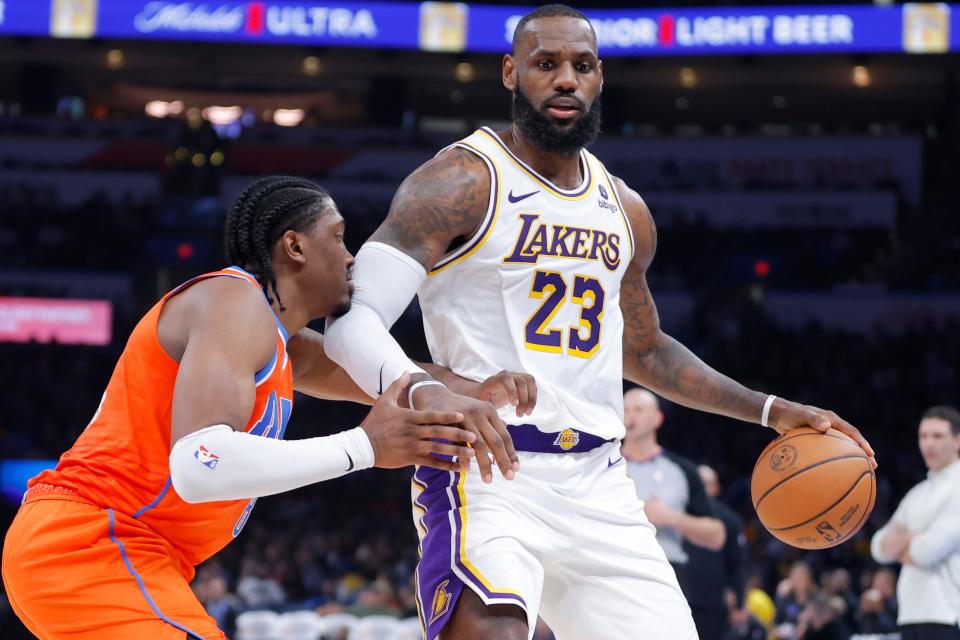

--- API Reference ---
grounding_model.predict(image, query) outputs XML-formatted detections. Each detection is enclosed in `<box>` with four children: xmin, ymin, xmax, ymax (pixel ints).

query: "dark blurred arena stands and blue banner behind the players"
<box><xmin>0</xmin><ymin>0</ymin><xmax>960</xmax><ymax>640</ymax></box>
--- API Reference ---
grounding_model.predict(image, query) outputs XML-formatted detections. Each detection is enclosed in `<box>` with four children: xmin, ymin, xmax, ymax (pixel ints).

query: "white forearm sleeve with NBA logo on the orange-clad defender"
<box><xmin>170</xmin><ymin>424</ymin><xmax>374</xmax><ymax>504</ymax></box>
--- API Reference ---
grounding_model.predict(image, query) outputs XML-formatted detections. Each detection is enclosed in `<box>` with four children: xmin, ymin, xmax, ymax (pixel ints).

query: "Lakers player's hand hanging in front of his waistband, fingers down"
<box><xmin>413</xmin><ymin>384</ymin><xmax>520</xmax><ymax>483</ymax></box>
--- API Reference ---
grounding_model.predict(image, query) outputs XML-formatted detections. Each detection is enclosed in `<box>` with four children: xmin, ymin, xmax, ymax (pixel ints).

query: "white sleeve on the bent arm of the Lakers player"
<box><xmin>323</xmin><ymin>242</ymin><xmax>427</xmax><ymax>398</ymax></box>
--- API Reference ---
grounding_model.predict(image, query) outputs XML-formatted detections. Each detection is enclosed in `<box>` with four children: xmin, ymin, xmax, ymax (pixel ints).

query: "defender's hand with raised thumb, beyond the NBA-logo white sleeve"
<box><xmin>360</xmin><ymin>373</ymin><xmax>477</xmax><ymax>471</ymax></box>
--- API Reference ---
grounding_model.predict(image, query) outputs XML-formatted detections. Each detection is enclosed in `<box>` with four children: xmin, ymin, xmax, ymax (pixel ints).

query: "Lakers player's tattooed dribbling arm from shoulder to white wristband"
<box><xmin>616</xmin><ymin>179</ymin><xmax>766</xmax><ymax>422</ymax></box>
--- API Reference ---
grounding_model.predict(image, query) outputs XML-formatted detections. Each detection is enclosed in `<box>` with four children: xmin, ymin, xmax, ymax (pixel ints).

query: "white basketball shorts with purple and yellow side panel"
<box><xmin>412</xmin><ymin>443</ymin><xmax>697</xmax><ymax>640</ymax></box>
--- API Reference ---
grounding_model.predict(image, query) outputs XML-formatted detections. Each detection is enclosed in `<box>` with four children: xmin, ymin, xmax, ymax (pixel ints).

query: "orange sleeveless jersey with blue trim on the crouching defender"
<box><xmin>29</xmin><ymin>267</ymin><xmax>293</xmax><ymax>579</ymax></box>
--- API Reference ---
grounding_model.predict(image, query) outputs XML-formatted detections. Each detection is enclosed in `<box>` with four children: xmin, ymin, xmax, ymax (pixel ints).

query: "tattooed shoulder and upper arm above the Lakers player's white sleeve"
<box><xmin>370</xmin><ymin>147</ymin><xmax>490</xmax><ymax>270</ymax></box>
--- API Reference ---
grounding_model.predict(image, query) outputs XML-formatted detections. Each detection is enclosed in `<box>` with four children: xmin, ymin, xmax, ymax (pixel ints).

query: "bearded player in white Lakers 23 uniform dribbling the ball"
<box><xmin>326</xmin><ymin>5</ymin><xmax>873</xmax><ymax>640</ymax></box>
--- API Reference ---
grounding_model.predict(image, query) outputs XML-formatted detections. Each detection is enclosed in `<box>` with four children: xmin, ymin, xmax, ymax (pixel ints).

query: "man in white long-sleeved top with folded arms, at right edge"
<box><xmin>871</xmin><ymin>406</ymin><xmax>960</xmax><ymax>640</ymax></box>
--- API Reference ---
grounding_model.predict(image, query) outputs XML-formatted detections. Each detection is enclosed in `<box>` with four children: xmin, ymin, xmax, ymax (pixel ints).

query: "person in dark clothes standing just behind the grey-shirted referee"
<box><xmin>684</xmin><ymin>465</ymin><xmax>747</xmax><ymax>638</ymax></box>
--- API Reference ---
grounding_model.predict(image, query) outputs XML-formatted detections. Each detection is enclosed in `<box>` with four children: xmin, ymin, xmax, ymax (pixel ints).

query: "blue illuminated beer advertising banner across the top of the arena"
<box><xmin>0</xmin><ymin>0</ymin><xmax>960</xmax><ymax>57</ymax></box>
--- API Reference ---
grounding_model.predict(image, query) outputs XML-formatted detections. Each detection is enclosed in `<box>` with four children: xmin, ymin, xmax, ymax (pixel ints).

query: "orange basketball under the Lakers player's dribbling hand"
<box><xmin>750</xmin><ymin>427</ymin><xmax>877</xmax><ymax>549</ymax></box>
